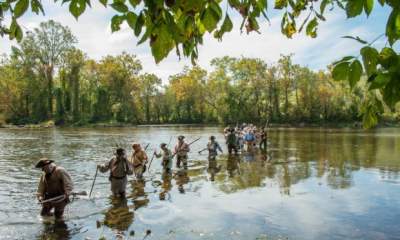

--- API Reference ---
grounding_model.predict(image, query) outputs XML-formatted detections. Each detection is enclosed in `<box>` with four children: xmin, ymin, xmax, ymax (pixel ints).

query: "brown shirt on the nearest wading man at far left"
<box><xmin>37</xmin><ymin>166</ymin><xmax>73</xmax><ymax>198</ymax></box>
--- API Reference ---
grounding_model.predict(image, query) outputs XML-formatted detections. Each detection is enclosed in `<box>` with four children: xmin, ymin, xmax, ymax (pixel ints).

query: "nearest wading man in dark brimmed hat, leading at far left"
<box><xmin>35</xmin><ymin>158</ymin><xmax>73</xmax><ymax>219</ymax></box>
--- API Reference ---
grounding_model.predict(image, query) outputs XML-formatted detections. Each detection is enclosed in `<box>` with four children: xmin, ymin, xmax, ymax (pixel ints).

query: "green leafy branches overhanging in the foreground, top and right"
<box><xmin>0</xmin><ymin>0</ymin><xmax>400</xmax><ymax>127</ymax></box>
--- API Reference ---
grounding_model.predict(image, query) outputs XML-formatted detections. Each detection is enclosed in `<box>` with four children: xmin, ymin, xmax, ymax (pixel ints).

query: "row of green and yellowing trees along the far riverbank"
<box><xmin>0</xmin><ymin>21</ymin><xmax>400</xmax><ymax>126</ymax></box>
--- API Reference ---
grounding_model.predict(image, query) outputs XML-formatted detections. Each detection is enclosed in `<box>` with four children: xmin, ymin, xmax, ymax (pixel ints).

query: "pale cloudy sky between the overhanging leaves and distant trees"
<box><xmin>0</xmin><ymin>1</ymin><xmax>390</xmax><ymax>83</ymax></box>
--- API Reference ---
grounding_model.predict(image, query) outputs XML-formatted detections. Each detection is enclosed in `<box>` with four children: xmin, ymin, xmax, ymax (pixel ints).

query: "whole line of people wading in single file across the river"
<box><xmin>35</xmin><ymin>125</ymin><xmax>266</xmax><ymax>219</ymax></box>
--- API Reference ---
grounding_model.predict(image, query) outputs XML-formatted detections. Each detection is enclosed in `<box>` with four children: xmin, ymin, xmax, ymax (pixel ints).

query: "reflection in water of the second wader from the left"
<box><xmin>104</xmin><ymin>197</ymin><xmax>134</xmax><ymax>235</ymax></box>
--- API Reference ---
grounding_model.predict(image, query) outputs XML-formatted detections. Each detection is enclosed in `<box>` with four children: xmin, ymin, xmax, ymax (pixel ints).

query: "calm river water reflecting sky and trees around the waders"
<box><xmin>0</xmin><ymin>126</ymin><xmax>400</xmax><ymax>239</ymax></box>
